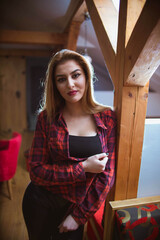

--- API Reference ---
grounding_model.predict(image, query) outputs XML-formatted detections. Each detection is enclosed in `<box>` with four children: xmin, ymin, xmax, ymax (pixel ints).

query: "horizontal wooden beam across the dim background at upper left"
<box><xmin>0</xmin><ymin>30</ymin><xmax>67</xmax><ymax>45</ymax></box>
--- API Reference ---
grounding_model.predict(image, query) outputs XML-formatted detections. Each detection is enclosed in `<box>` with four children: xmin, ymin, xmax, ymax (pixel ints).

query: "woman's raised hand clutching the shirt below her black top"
<box><xmin>82</xmin><ymin>153</ymin><xmax>108</xmax><ymax>173</ymax></box>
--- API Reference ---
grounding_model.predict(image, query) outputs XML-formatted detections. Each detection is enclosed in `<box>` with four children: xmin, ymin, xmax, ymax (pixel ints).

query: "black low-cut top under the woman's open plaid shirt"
<box><xmin>69</xmin><ymin>134</ymin><xmax>102</xmax><ymax>158</ymax></box>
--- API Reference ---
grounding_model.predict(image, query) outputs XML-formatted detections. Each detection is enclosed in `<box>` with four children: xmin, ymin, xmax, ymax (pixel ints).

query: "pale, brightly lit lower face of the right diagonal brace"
<box><xmin>125</xmin><ymin>20</ymin><xmax>160</xmax><ymax>86</ymax></box>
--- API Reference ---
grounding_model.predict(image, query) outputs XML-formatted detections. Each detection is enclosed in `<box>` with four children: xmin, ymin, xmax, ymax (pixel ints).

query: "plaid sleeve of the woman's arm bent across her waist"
<box><xmin>28</xmin><ymin>113</ymin><xmax>86</xmax><ymax>187</ymax></box>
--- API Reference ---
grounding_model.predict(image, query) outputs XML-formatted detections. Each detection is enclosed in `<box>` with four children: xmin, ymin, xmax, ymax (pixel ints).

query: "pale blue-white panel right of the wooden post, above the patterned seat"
<box><xmin>137</xmin><ymin>119</ymin><xmax>160</xmax><ymax>197</ymax></box>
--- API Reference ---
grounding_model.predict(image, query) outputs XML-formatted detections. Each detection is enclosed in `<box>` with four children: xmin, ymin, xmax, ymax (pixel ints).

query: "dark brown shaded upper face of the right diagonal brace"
<box><xmin>125</xmin><ymin>0</ymin><xmax>160</xmax><ymax>83</ymax></box>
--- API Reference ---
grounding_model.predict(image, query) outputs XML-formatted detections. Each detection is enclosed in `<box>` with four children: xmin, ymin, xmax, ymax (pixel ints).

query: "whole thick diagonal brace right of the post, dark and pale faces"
<box><xmin>124</xmin><ymin>0</ymin><xmax>160</xmax><ymax>86</ymax></box>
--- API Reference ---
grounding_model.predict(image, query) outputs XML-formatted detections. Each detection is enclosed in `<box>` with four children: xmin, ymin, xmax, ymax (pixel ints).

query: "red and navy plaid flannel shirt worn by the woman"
<box><xmin>29</xmin><ymin>110</ymin><xmax>116</xmax><ymax>224</ymax></box>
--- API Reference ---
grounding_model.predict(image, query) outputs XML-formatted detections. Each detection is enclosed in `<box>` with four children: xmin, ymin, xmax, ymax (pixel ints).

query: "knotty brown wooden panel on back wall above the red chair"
<box><xmin>0</xmin><ymin>57</ymin><xmax>27</xmax><ymax>132</ymax></box>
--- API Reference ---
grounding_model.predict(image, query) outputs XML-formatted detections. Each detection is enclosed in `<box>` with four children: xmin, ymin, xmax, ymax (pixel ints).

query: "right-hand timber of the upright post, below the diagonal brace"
<box><xmin>127</xmin><ymin>83</ymin><xmax>149</xmax><ymax>198</ymax></box>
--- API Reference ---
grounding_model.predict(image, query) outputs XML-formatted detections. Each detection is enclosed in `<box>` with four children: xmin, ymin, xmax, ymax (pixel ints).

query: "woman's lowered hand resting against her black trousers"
<box><xmin>59</xmin><ymin>215</ymin><xmax>79</xmax><ymax>233</ymax></box>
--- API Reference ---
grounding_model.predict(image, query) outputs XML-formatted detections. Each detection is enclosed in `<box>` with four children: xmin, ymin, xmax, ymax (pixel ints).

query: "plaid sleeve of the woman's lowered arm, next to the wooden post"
<box><xmin>71</xmin><ymin>109</ymin><xmax>116</xmax><ymax>224</ymax></box>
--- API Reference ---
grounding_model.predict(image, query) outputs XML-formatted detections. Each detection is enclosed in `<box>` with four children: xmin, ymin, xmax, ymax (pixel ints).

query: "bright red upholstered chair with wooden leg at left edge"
<box><xmin>0</xmin><ymin>132</ymin><xmax>22</xmax><ymax>199</ymax></box>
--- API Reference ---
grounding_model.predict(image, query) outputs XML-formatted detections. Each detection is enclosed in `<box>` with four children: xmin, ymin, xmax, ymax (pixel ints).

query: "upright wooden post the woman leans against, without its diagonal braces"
<box><xmin>114</xmin><ymin>0</ymin><xmax>148</xmax><ymax>200</ymax></box>
